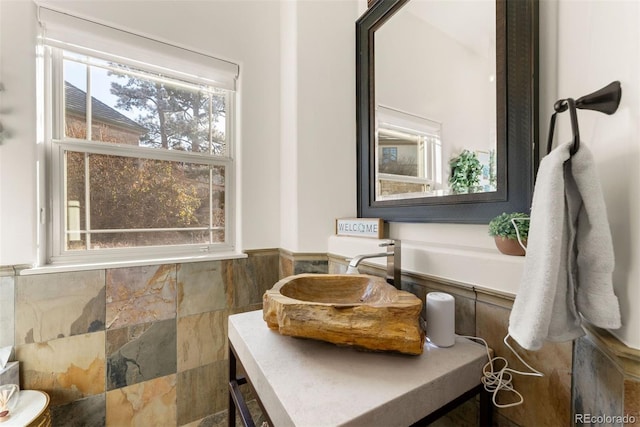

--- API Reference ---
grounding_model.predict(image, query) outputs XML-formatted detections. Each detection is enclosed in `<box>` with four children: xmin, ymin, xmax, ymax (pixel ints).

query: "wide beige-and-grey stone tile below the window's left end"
<box><xmin>15</xmin><ymin>270</ymin><xmax>105</xmax><ymax>344</ymax></box>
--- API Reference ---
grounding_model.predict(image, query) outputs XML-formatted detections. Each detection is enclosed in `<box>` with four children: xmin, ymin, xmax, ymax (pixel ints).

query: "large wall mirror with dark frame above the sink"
<box><xmin>356</xmin><ymin>0</ymin><xmax>538</xmax><ymax>223</ymax></box>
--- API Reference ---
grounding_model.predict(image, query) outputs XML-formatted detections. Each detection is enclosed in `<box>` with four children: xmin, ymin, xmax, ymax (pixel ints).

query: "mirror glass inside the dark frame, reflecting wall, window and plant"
<box><xmin>375</xmin><ymin>0</ymin><xmax>497</xmax><ymax>201</ymax></box>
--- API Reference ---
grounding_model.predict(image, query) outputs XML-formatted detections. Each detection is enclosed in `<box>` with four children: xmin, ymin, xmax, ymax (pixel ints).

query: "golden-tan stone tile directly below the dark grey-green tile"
<box><xmin>106</xmin><ymin>374</ymin><xmax>176</xmax><ymax>427</ymax></box>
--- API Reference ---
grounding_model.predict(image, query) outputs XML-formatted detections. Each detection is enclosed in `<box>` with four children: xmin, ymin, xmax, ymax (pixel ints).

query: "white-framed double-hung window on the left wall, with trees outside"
<box><xmin>41</xmin><ymin>7</ymin><xmax>240</xmax><ymax>263</ymax></box>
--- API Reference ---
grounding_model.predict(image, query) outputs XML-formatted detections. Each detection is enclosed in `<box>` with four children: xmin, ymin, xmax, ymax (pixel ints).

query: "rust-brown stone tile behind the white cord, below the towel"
<box><xmin>476</xmin><ymin>301</ymin><xmax>572</xmax><ymax>426</ymax></box>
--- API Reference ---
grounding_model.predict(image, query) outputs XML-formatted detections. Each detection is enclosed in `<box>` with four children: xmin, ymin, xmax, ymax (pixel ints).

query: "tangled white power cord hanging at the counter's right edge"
<box><xmin>462</xmin><ymin>334</ymin><xmax>544</xmax><ymax>408</ymax></box>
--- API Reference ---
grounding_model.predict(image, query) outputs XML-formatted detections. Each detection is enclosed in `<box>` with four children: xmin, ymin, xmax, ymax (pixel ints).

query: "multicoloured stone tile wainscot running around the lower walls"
<box><xmin>0</xmin><ymin>249</ymin><xmax>640</xmax><ymax>427</ymax></box>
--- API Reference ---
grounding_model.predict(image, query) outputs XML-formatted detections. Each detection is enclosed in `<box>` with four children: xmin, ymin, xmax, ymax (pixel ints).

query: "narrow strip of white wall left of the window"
<box><xmin>0</xmin><ymin>1</ymin><xmax>36</xmax><ymax>265</ymax></box>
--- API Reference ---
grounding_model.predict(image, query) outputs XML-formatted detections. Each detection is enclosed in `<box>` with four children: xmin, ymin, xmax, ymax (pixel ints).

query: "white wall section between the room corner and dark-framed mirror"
<box><xmin>281</xmin><ymin>0</ymin><xmax>359</xmax><ymax>252</ymax></box>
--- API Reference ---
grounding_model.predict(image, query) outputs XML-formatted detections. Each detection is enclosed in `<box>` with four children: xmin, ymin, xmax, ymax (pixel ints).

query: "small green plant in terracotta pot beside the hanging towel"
<box><xmin>489</xmin><ymin>212</ymin><xmax>529</xmax><ymax>256</ymax></box>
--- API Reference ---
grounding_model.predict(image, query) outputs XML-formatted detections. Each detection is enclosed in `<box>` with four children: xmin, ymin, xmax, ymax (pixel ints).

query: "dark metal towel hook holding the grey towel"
<box><xmin>547</xmin><ymin>81</ymin><xmax>622</xmax><ymax>156</ymax></box>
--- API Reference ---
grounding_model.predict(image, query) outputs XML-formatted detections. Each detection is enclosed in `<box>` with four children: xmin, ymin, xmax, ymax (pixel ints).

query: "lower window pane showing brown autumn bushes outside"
<box><xmin>65</xmin><ymin>151</ymin><xmax>225</xmax><ymax>250</ymax></box>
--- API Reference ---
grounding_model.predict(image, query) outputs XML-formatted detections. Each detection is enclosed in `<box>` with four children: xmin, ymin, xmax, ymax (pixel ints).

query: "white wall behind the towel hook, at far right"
<box><xmin>556</xmin><ymin>0</ymin><xmax>640</xmax><ymax>348</ymax></box>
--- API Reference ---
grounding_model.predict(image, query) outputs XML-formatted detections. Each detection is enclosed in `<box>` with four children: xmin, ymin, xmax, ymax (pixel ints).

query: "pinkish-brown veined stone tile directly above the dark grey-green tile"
<box><xmin>106</xmin><ymin>264</ymin><xmax>176</xmax><ymax>329</ymax></box>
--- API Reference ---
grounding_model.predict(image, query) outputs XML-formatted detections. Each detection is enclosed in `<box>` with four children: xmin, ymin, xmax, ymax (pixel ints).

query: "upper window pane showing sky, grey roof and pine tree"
<box><xmin>64</xmin><ymin>51</ymin><xmax>227</xmax><ymax>155</ymax></box>
